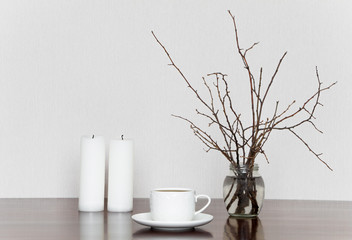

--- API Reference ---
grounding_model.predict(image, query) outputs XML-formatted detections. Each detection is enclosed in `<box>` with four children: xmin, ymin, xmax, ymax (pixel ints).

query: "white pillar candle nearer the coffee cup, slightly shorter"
<box><xmin>108</xmin><ymin>137</ymin><xmax>133</xmax><ymax>212</ymax></box>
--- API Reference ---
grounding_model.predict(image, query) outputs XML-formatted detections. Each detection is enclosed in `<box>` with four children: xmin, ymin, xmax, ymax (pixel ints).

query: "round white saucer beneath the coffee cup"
<box><xmin>132</xmin><ymin>213</ymin><xmax>213</xmax><ymax>231</ymax></box>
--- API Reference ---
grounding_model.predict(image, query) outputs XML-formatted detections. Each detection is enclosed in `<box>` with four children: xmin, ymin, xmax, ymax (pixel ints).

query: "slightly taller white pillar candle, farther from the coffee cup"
<box><xmin>78</xmin><ymin>135</ymin><xmax>105</xmax><ymax>212</ymax></box>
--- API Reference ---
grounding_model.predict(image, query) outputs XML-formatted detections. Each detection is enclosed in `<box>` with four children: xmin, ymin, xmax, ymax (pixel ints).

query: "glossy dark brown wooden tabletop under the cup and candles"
<box><xmin>0</xmin><ymin>199</ymin><xmax>352</xmax><ymax>240</ymax></box>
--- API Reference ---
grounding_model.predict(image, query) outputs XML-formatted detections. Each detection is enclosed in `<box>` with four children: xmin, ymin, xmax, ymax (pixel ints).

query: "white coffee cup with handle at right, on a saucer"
<box><xmin>150</xmin><ymin>188</ymin><xmax>211</xmax><ymax>222</ymax></box>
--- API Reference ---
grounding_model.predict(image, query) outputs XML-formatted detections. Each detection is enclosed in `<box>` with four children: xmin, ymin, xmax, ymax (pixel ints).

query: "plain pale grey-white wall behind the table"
<box><xmin>0</xmin><ymin>0</ymin><xmax>352</xmax><ymax>200</ymax></box>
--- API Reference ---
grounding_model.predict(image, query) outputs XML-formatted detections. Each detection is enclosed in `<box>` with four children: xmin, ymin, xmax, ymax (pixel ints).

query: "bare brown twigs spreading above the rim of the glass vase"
<box><xmin>152</xmin><ymin>11</ymin><xmax>337</xmax><ymax>170</ymax></box>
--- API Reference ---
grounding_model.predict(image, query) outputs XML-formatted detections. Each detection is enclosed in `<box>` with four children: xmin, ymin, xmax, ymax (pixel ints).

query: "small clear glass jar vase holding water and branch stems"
<box><xmin>223</xmin><ymin>164</ymin><xmax>265</xmax><ymax>218</ymax></box>
